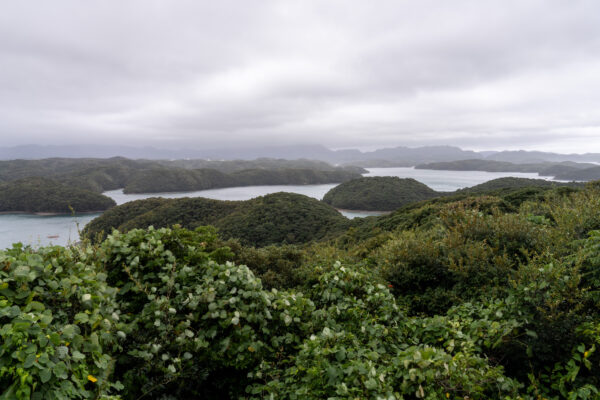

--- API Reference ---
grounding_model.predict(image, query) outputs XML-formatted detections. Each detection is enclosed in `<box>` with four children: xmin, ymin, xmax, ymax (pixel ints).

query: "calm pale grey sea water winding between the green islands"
<box><xmin>0</xmin><ymin>168</ymin><xmax>539</xmax><ymax>249</ymax></box>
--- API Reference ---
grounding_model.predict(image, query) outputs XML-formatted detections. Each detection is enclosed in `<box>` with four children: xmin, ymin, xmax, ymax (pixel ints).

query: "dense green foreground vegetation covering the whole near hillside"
<box><xmin>0</xmin><ymin>184</ymin><xmax>600</xmax><ymax>400</ymax></box>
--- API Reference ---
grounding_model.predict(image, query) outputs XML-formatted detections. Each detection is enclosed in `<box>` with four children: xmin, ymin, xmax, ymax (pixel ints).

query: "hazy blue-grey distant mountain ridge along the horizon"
<box><xmin>0</xmin><ymin>144</ymin><xmax>600</xmax><ymax>167</ymax></box>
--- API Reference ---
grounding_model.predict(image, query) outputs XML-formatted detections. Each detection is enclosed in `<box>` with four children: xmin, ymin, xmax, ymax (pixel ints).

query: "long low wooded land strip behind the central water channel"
<box><xmin>119</xmin><ymin>168</ymin><xmax>360</xmax><ymax>193</ymax></box>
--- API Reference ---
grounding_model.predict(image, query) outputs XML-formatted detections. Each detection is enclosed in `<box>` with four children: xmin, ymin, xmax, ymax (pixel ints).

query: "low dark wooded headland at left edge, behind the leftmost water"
<box><xmin>0</xmin><ymin>178</ymin><xmax>116</xmax><ymax>213</ymax></box>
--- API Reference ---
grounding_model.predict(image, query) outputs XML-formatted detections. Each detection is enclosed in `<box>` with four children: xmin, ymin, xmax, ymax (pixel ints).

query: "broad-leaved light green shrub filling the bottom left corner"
<box><xmin>0</xmin><ymin>245</ymin><xmax>124</xmax><ymax>400</ymax></box>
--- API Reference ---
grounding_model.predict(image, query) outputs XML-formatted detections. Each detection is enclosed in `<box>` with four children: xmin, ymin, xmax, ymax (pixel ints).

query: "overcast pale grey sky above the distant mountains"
<box><xmin>0</xmin><ymin>0</ymin><xmax>600</xmax><ymax>152</ymax></box>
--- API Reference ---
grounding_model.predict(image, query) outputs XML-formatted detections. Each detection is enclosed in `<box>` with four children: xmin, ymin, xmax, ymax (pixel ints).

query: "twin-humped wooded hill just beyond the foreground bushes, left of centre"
<box><xmin>84</xmin><ymin>192</ymin><xmax>348</xmax><ymax>246</ymax></box>
